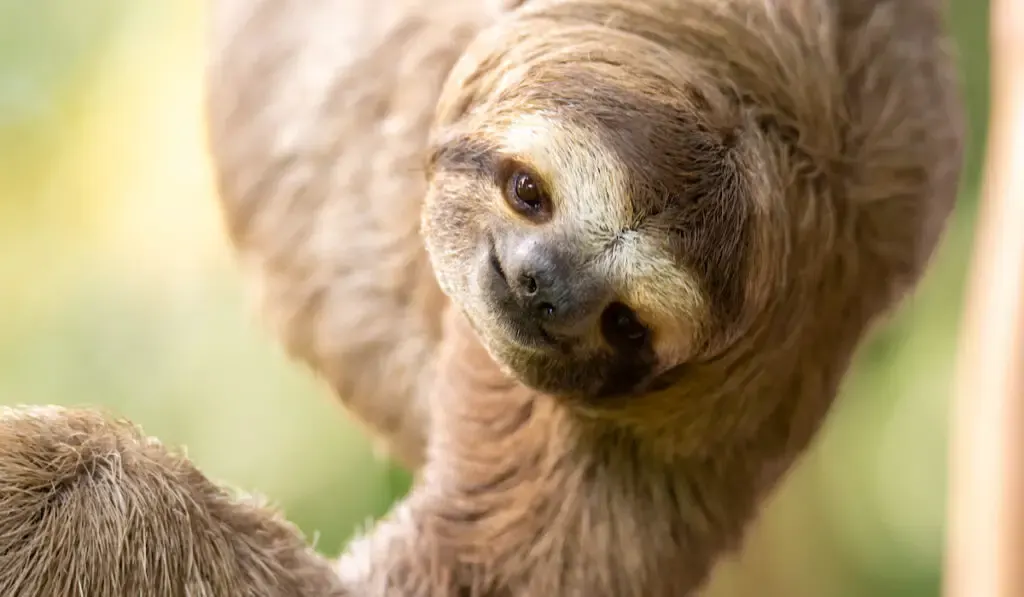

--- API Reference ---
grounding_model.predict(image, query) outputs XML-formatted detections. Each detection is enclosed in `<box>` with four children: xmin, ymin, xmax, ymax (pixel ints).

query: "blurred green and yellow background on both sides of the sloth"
<box><xmin>0</xmin><ymin>0</ymin><xmax>988</xmax><ymax>597</ymax></box>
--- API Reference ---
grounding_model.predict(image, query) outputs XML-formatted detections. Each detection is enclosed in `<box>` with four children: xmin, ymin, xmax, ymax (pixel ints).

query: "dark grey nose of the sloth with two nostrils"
<box><xmin>505</xmin><ymin>240</ymin><xmax>607</xmax><ymax>337</ymax></box>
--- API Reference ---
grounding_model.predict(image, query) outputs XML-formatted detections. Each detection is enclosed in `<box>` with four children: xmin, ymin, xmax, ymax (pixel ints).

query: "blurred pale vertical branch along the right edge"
<box><xmin>945</xmin><ymin>0</ymin><xmax>1024</xmax><ymax>597</ymax></box>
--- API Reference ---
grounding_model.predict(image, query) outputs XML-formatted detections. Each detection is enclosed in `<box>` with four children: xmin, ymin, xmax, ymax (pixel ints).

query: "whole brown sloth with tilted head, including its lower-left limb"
<box><xmin>0</xmin><ymin>0</ymin><xmax>964</xmax><ymax>597</ymax></box>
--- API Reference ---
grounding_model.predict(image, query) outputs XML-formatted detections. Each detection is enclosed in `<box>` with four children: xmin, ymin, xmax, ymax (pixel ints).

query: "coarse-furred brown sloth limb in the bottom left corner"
<box><xmin>0</xmin><ymin>408</ymin><xmax>343</xmax><ymax>597</ymax></box>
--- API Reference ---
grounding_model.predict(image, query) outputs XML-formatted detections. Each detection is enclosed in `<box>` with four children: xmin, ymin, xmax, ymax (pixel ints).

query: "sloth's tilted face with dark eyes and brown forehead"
<box><xmin>424</xmin><ymin>67</ymin><xmax>750</xmax><ymax>400</ymax></box>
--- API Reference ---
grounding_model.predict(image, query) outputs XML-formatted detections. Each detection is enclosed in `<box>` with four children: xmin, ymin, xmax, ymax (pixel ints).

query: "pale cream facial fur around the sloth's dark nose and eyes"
<box><xmin>425</xmin><ymin>112</ymin><xmax>707</xmax><ymax>401</ymax></box>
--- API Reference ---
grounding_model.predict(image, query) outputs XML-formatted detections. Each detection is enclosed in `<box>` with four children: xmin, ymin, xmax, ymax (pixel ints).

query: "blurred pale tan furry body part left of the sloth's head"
<box><xmin>206</xmin><ymin>0</ymin><xmax>504</xmax><ymax>468</ymax></box>
